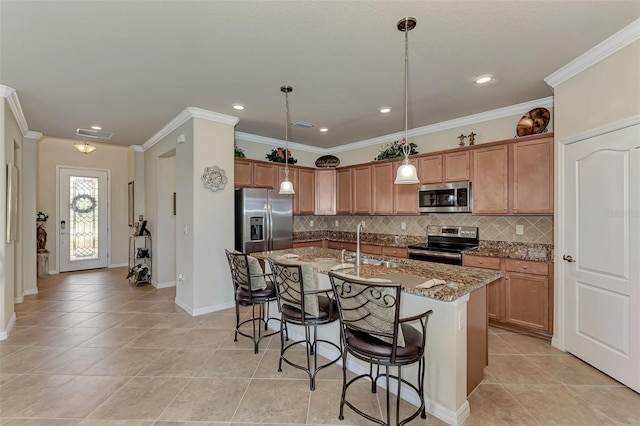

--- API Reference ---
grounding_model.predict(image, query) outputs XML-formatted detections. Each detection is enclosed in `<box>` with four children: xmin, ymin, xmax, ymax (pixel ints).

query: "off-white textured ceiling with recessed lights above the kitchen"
<box><xmin>0</xmin><ymin>0</ymin><xmax>640</xmax><ymax>148</ymax></box>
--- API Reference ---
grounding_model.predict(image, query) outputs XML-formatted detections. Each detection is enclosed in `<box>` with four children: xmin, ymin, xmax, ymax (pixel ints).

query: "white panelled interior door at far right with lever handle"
<box><xmin>562</xmin><ymin>125</ymin><xmax>640</xmax><ymax>392</ymax></box>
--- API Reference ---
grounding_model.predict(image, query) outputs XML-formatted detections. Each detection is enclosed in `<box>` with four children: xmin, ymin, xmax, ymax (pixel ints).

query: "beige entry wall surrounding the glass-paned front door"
<box><xmin>37</xmin><ymin>136</ymin><xmax>133</xmax><ymax>271</ymax></box>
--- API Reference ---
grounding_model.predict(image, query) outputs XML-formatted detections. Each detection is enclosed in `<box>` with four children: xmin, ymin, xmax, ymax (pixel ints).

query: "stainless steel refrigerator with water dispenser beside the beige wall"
<box><xmin>235</xmin><ymin>188</ymin><xmax>293</xmax><ymax>253</ymax></box>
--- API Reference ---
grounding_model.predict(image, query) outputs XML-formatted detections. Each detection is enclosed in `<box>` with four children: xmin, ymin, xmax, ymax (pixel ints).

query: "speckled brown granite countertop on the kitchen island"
<box><xmin>252</xmin><ymin>247</ymin><xmax>502</xmax><ymax>302</ymax></box>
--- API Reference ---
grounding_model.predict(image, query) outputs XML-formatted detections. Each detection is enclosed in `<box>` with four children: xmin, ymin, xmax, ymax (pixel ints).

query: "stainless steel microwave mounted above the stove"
<box><xmin>418</xmin><ymin>182</ymin><xmax>473</xmax><ymax>213</ymax></box>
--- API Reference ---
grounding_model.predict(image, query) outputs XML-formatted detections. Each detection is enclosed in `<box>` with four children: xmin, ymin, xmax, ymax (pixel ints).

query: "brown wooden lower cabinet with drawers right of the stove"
<box><xmin>463</xmin><ymin>255</ymin><xmax>553</xmax><ymax>337</ymax></box>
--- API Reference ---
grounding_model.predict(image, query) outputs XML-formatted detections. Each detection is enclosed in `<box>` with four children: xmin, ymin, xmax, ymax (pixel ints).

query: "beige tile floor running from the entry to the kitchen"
<box><xmin>0</xmin><ymin>268</ymin><xmax>640</xmax><ymax>426</ymax></box>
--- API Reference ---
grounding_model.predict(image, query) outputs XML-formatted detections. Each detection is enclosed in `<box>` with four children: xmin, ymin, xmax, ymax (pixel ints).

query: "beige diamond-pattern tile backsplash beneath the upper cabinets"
<box><xmin>293</xmin><ymin>213</ymin><xmax>553</xmax><ymax>244</ymax></box>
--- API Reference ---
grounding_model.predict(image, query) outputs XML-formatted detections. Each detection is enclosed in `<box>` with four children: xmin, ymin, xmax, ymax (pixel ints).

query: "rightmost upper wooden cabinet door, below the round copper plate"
<box><xmin>511</xmin><ymin>137</ymin><xmax>553</xmax><ymax>214</ymax></box>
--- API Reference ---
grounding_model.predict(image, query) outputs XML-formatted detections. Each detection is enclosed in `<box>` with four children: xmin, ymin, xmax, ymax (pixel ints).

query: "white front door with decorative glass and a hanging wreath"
<box><xmin>58</xmin><ymin>167</ymin><xmax>109</xmax><ymax>272</ymax></box>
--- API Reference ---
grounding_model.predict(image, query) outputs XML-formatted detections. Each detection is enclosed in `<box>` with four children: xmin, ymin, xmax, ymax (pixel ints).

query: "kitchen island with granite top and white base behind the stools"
<box><xmin>253</xmin><ymin>247</ymin><xmax>502</xmax><ymax>425</ymax></box>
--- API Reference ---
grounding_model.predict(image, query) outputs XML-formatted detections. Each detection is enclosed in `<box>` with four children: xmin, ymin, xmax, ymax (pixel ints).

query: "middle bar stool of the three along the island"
<box><xmin>269</xmin><ymin>259</ymin><xmax>342</xmax><ymax>390</ymax></box>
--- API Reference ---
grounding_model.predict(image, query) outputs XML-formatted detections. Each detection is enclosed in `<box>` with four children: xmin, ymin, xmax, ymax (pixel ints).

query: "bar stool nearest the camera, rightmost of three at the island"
<box><xmin>329</xmin><ymin>272</ymin><xmax>432</xmax><ymax>425</ymax></box>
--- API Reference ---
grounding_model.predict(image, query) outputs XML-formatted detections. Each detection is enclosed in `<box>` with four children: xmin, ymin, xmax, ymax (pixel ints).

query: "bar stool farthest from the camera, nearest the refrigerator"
<box><xmin>224</xmin><ymin>250</ymin><xmax>282</xmax><ymax>353</ymax></box>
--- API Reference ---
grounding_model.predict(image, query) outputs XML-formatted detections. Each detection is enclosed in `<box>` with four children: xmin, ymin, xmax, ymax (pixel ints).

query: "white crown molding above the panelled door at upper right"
<box><xmin>544</xmin><ymin>19</ymin><xmax>640</xmax><ymax>88</ymax></box>
